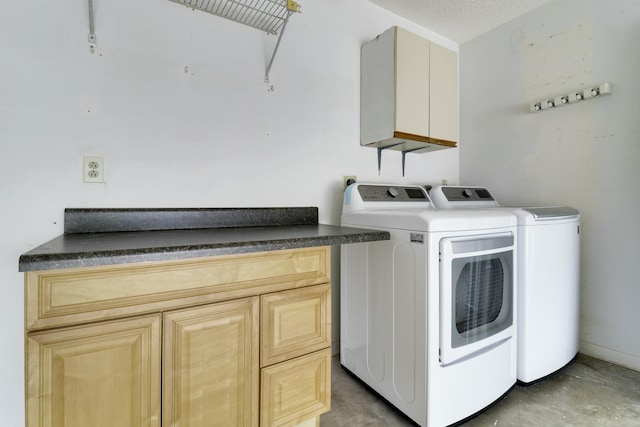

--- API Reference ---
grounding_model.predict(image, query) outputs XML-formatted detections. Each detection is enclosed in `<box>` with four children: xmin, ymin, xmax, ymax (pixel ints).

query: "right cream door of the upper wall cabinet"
<box><xmin>429</xmin><ymin>43</ymin><xmax>458</xmax><ymax>141</ymax></box>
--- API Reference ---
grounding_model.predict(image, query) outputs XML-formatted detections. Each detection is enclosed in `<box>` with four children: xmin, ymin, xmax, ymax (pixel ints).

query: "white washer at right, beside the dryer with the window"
<box><xmin>429</xmin><ymin>186</ymin><xmax>580</xmax><ymax>384</ymax></box>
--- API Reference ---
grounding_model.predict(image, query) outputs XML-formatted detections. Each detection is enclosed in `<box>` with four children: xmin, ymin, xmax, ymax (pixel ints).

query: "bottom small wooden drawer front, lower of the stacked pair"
<box><xmin>260</xmin><ymin>349</ymin><xmax>331</xmax><ymax>426</ymax></box>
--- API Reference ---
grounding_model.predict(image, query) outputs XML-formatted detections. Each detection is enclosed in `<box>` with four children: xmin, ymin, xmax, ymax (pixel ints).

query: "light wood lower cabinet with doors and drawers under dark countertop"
<box><xmin>25</xmin><ymin>247</ymin><xmax>331</xmax><ymax>427</ymax></box>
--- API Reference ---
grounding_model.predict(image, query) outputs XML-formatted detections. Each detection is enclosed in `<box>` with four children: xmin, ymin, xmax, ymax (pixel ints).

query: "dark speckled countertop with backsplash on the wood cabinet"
<box><xmin>19</xmin><ymin>207</ymin><xmax>389</xmax><ymax>271</ymax></box>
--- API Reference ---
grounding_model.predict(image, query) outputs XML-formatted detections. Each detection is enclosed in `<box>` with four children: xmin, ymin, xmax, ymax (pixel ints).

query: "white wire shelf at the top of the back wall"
<box><xmin>171</xmin><ymin>0</ymin><xmax>299</xmax><ymax>34</ymax></box>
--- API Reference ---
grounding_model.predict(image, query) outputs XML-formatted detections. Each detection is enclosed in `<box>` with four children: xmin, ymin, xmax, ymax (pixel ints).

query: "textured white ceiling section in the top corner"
<box><xmin>369</xmin><ymin>0</ymin><xmax>551</xmax><ymax>44</ymax></box>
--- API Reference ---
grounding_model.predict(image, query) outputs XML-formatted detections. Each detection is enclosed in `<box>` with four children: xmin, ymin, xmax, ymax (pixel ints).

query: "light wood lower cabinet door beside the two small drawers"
<box><xmin>163</xmin><ymin>297</ymin><xmax>259</xmax><ymax>427</ymax></box>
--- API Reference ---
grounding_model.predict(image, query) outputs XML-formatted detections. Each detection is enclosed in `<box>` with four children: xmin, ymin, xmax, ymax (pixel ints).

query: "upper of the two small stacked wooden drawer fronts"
<box><xmin>260</xmin><ymin>284</ymin><xmax>331</xmax><ymax>366</ymax></box>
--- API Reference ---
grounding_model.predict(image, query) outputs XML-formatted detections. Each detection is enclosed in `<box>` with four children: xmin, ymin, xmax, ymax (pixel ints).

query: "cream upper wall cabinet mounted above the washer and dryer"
<box><xmin>360</xmin><ymin>27</ymin><xmax>458</xmax><ymax>152</ymax></box>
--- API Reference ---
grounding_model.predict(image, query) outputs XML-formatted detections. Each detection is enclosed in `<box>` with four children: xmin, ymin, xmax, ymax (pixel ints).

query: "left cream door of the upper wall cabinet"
<box><xmin>396</xmin><ymin>28</ymin><xmax>433</xmax><ymax>136</ymax></box>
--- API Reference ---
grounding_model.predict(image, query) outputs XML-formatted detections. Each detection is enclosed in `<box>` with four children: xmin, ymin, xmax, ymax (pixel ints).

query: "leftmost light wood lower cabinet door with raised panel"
<box><xmin>26</xmin><ymin>315</ymin><xmax>161</xmax><ymax>427</ymax></box>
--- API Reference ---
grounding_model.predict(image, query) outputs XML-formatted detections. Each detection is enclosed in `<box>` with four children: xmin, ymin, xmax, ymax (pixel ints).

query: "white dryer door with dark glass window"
<box><xmin>440</xmin><ymin>233</ymin><xmax>515</xmax><ymax>365</ymax></box>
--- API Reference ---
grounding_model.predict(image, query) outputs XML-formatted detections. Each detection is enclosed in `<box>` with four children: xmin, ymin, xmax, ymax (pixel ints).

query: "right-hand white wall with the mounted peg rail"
<box><xmin>459</xmin><ymin>0</ymin><xmax>640</xmax><ymax>370</ymax></box>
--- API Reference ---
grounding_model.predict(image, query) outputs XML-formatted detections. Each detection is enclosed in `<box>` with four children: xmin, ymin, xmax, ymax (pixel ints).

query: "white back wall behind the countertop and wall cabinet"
<box><xmin>0</xmin><ymin>0</ymin><xmax>458</xmax><ymax>426</ymax></box>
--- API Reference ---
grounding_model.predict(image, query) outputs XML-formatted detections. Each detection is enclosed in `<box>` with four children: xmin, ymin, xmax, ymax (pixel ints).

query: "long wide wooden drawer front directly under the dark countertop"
<box><xmin>25</xmin><ymin>247</ymin><xmax>330</xmax><ymax>330</ymax></box>
